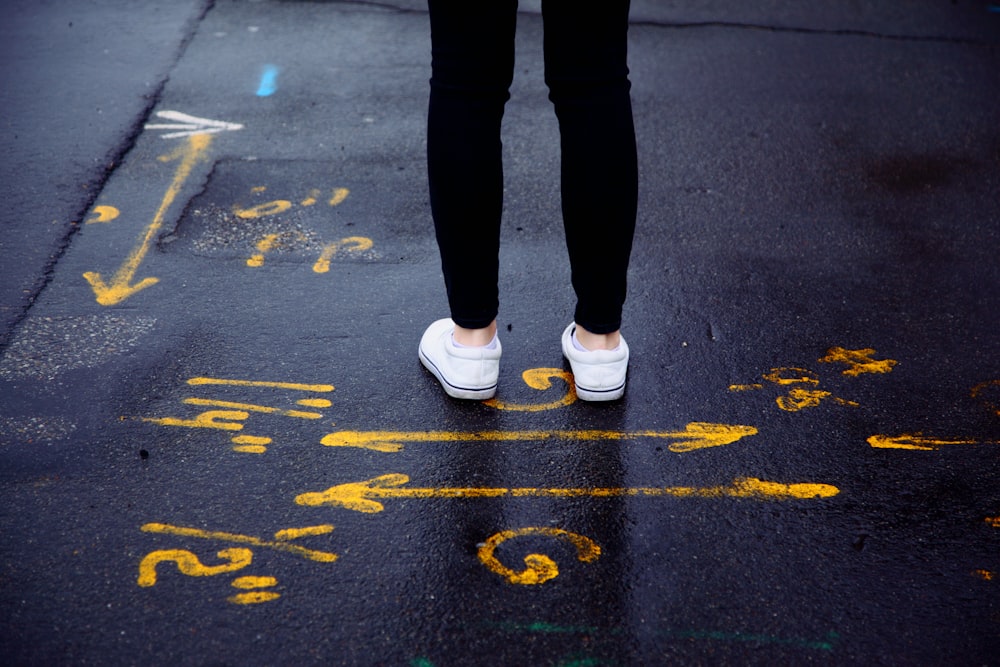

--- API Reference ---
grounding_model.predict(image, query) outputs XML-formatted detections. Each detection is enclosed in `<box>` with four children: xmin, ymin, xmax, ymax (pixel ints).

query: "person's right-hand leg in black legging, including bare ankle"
<box><xmin>542</xmin><ymin>0</ymin><xmax>638</xmax><ymax>349</ymax></box>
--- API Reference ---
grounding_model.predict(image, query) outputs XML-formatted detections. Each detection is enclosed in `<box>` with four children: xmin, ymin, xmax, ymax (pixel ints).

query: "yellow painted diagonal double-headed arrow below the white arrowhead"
<box><xmin>83</xmin><ymin>134</ymin><xmax>212</xmax><ymax>306</ymax></box>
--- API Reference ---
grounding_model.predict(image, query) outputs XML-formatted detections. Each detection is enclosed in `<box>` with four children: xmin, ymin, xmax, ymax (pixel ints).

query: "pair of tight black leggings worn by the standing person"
<box><xmin>427</xmin><ymin>0</ymin><xmax>638</xmax><ymax>334</ymax></box>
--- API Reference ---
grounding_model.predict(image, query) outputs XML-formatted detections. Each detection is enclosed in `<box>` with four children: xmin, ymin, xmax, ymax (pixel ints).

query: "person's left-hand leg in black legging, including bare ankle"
<box><xmin>427</xmin><ymin>0</ymin><xmax>517</xmax><ymax>336</ymax></box>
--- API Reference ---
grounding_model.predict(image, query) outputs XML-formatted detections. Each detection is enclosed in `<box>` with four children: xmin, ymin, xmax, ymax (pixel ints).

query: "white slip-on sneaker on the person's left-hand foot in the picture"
<box><xmin>418</xmin><ymin>318</ymin><xmax>502</xmax><ymax>401</ymax></box>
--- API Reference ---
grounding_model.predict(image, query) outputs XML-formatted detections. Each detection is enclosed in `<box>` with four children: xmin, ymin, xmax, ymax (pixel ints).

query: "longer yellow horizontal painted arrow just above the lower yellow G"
<box><xmin>295</xmin><ymin>474</ymin><xmax>840</xmax><ymax>514</ymax></box>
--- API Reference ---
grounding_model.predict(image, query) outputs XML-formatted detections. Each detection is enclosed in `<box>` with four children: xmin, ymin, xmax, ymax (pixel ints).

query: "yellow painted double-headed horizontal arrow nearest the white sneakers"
<box><xmin>321</xmin><ymin>422</ymin><xmax>757</xmax><ymax>453</ymax></box>
